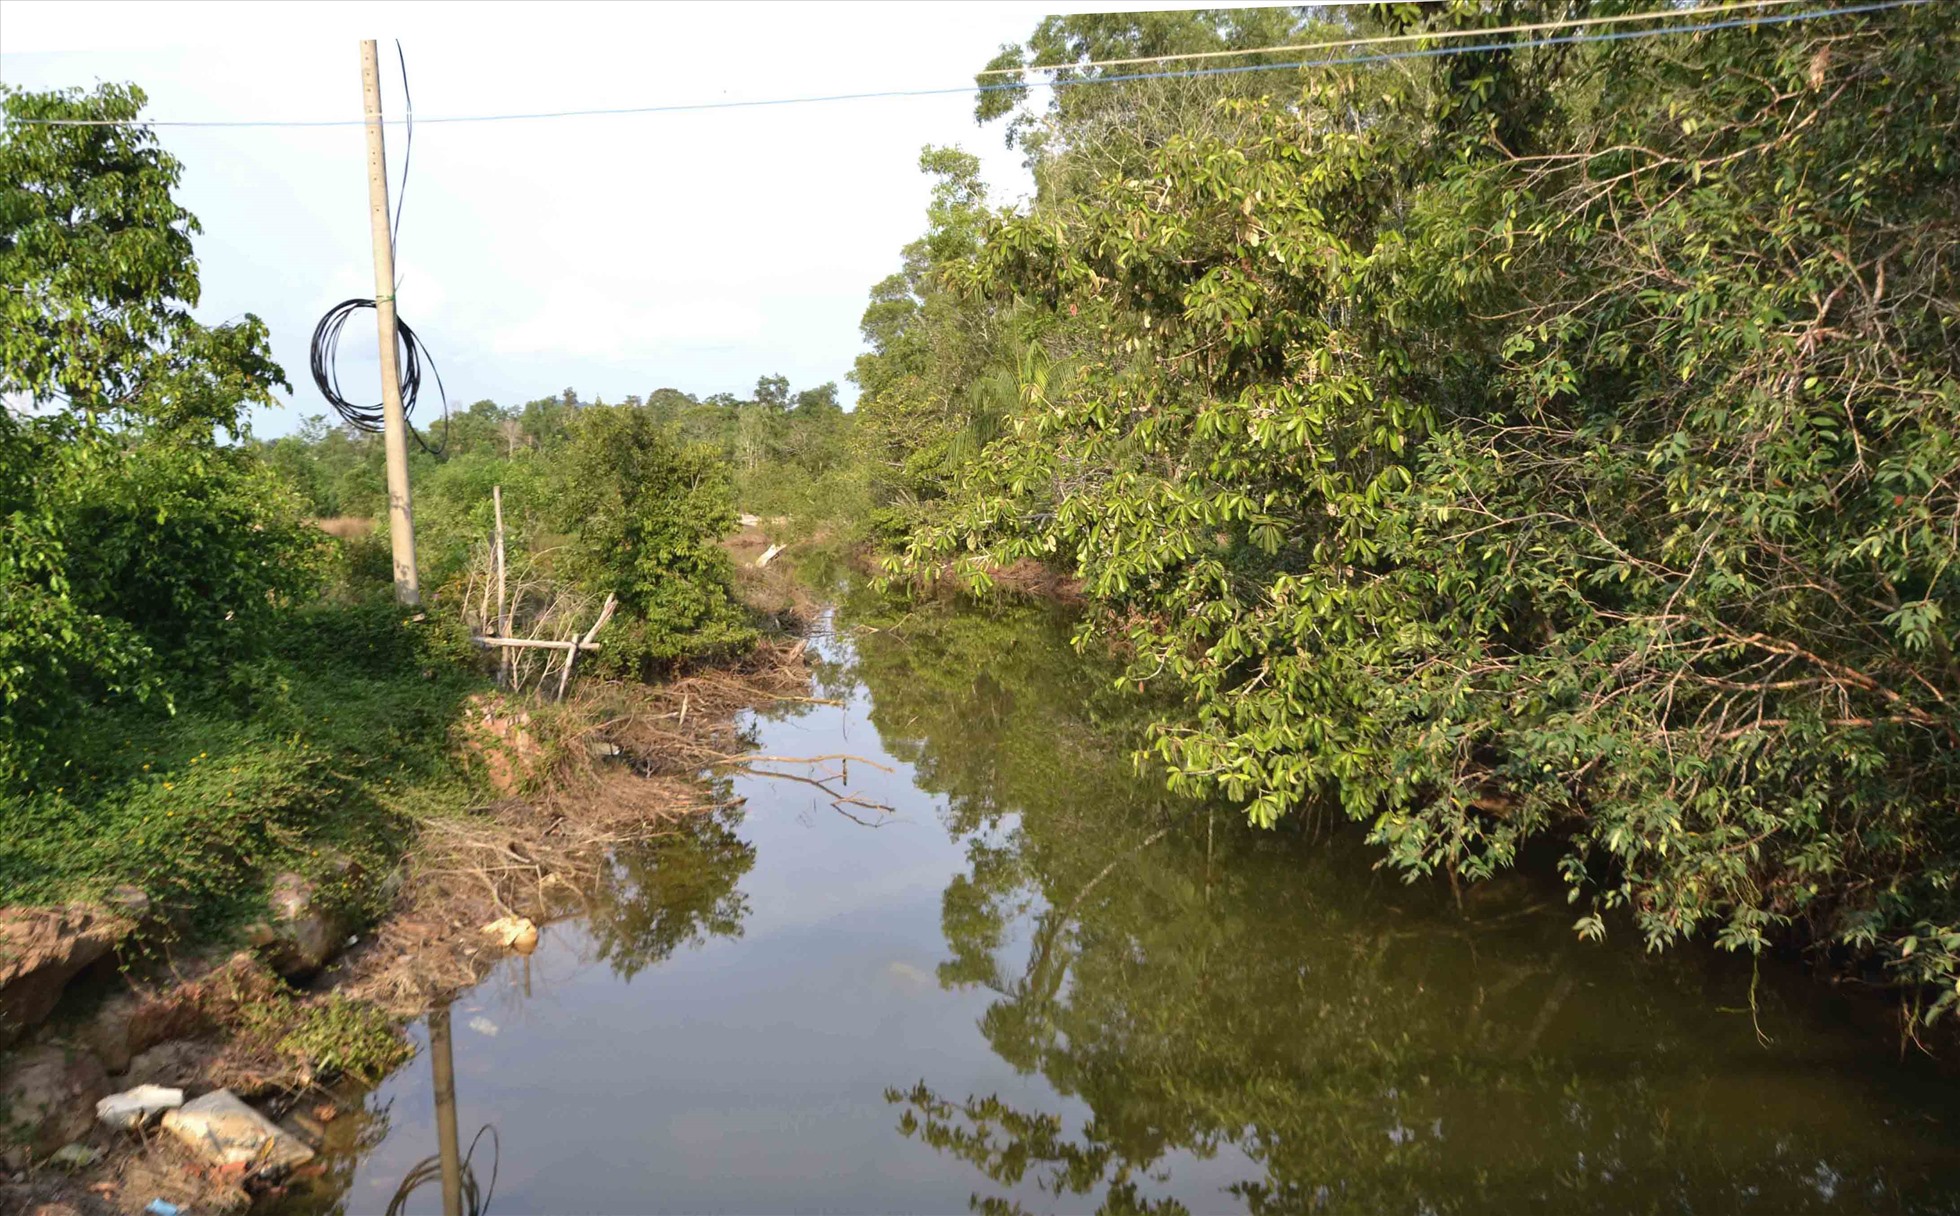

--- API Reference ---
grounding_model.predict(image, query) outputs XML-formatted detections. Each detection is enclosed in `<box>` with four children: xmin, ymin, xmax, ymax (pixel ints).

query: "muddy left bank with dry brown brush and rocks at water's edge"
<box><xmin>0</xmin><ymin>639</ymin><xmax>809</xmax><ymax>1216</ymax></box>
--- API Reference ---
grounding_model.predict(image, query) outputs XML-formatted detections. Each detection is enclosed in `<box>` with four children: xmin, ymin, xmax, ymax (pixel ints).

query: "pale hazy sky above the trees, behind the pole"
<box><xmin>0</xmin><ymin>0</ymin><xmax>1262</xmax><ymax>435</ymax></box>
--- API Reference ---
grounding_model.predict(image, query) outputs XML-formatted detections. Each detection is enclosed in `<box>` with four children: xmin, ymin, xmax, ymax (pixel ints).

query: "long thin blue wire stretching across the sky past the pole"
<box><xmin>8</xmin><ymin>0</ymin><xmax>1933</xmax><ymax>127</ymax></box>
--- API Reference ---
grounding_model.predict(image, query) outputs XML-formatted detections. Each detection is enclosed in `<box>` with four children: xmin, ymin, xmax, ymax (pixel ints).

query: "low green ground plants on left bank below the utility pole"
<box><xmin>0</xmin><ymin>602</ymin><xmax>480</xmax><ymax>932</ymax></box>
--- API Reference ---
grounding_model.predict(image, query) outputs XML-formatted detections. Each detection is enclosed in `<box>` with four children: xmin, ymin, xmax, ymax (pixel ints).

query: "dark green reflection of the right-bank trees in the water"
<box><xmin>845</xmin><ymin>588</ymin><xmax>1960</xmax><ymax>1212</ymax></box>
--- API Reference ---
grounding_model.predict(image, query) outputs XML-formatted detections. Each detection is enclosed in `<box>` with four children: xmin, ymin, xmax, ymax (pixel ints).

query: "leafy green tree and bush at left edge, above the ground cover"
<box><xmin>0</xmin><ymin>84</ymin><xmax>319</xmax><ymax>783</ymax></box>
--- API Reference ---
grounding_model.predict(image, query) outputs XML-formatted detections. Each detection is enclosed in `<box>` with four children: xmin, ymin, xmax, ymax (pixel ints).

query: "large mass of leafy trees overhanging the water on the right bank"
<box><xmin>858</xmin><ymin>2</ymin><xmax>1960</xmax><ymax>1010</ymax></box>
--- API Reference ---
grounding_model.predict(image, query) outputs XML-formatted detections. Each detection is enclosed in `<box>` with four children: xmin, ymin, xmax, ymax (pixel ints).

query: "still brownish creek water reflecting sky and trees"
<box><xmin>272</xmin><ymin>588</ymin><xmax>1960</xmax><ymax>1214</ymax></box>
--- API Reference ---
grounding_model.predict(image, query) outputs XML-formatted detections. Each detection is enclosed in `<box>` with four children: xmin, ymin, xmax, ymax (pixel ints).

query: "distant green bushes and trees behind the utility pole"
<box><xmin>257</xmin><ymin>377</ymin><xmax>862</xmax><ymax>675</ymax></box>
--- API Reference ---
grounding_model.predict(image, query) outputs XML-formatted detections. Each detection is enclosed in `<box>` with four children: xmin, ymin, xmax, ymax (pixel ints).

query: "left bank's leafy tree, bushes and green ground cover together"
<box><xmin>0</xmin><ymin>86</ymin><xmax>505</xmax><ymax>930</ymax></box>
